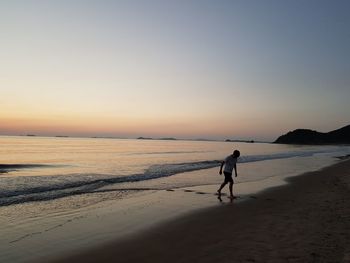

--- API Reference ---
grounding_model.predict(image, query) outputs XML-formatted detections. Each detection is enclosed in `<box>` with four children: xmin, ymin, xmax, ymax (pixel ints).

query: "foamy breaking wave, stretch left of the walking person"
<box><xmin>0</xmin><ymin>161</ymin><xmax>219</xmax><ymax>206</ymax></box>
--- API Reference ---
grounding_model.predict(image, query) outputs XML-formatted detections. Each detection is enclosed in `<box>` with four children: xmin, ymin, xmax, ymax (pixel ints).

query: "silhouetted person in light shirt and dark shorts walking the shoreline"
<box><xmin>218</xmin><ymin>150</ymin><xmax>241</xmax><ymax>200</ymax></box>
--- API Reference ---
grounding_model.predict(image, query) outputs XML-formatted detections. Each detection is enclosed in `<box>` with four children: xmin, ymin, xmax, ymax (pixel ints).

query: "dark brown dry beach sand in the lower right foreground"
<box><xmin>55</xmin><ymin>160</ymin><xmax>350</xmax><ymax>262</ymax></box>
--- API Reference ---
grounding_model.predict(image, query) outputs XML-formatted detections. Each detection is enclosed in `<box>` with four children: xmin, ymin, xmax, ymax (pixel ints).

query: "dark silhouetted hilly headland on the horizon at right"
<box><xmin>274</xmin><ymin>125</ymin><xmax>350</xmax><ymax>145</ymax></box>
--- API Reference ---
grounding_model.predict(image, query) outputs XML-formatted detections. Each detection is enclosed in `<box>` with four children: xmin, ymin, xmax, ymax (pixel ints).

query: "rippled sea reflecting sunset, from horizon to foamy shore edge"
<box><xmin>0</xmin><ymin>136</ymin><xmax>350</xmax><ymax>207</ymax></box>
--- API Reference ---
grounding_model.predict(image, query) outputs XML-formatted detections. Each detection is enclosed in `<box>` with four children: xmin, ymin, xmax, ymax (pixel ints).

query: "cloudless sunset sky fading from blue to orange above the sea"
<box><xmin>0</xmin><ymin>0</ymin><xmax>350</xmax><ymax>140</ymax></box>
